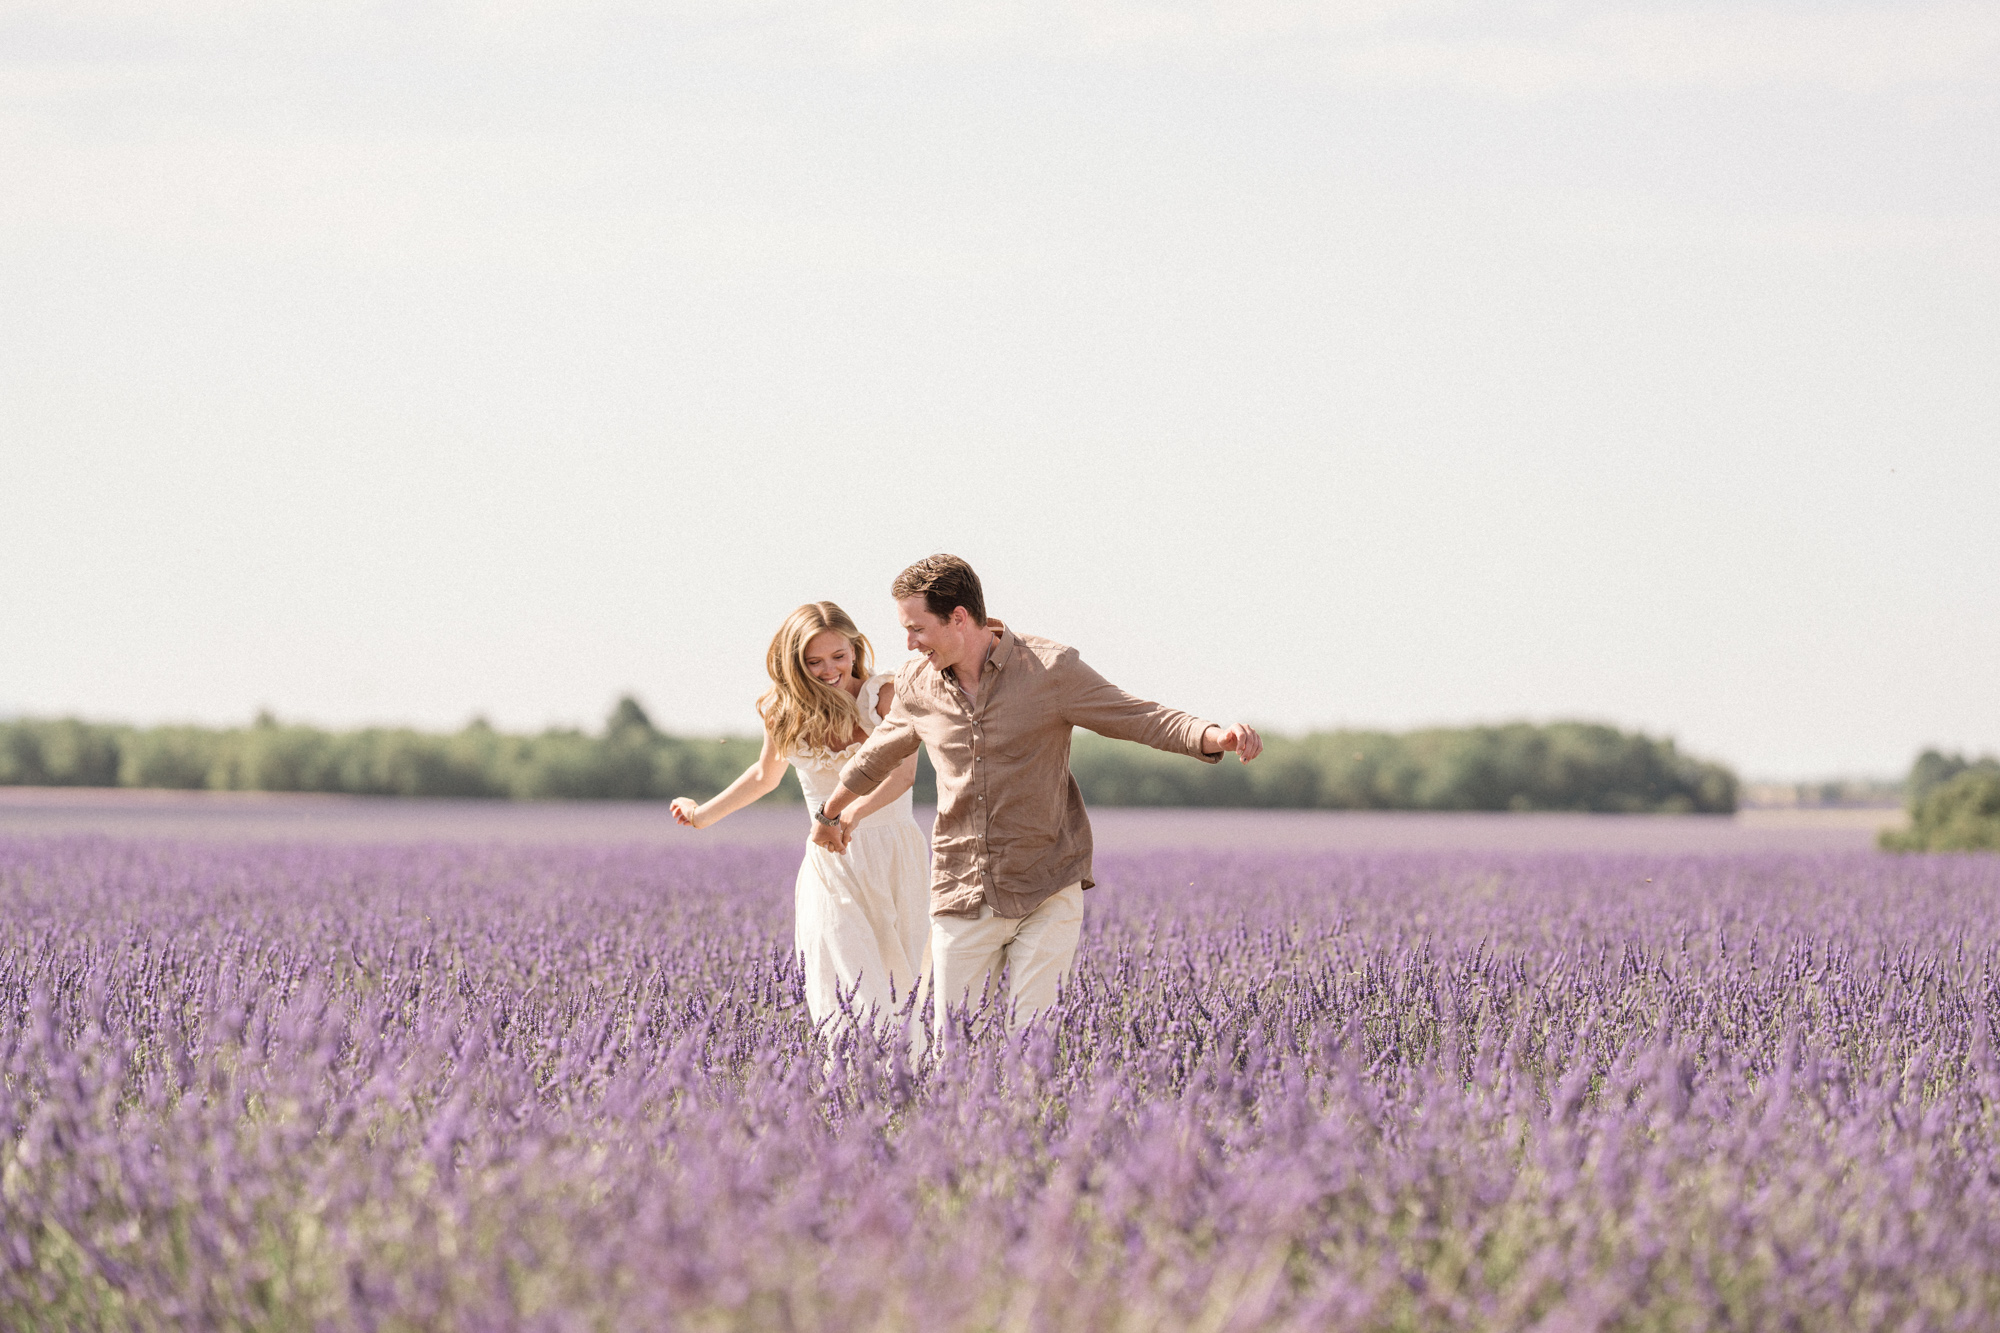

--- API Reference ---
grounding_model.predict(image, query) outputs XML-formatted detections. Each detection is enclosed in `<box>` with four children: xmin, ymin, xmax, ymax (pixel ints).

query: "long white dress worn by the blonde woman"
<box><xmin>790</xmin><ymin>675</ymin><xmax>930</xmax><ymax>1027</ymax></box>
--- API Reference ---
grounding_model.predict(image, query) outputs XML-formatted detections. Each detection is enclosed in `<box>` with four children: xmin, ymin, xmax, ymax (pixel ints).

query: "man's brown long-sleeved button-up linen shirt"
<box><xmin>840</xmin><ymin>620</ymin><xmax>1222</xmax><ymax>917</ymax></box>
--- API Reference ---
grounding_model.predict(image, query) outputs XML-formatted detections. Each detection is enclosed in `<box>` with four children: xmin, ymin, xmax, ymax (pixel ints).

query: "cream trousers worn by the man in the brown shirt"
<box><xmin>930</xmin><ymin>881</ymin><xmax>1084</xmax><ymax>1037</ymax></box>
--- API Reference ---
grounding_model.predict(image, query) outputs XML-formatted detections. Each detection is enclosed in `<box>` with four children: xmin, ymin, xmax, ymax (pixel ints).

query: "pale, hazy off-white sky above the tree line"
<box><xmin>0</xmin><ymin>0</ymin><xmax>2000</xmax><ymax>777</ymax></box>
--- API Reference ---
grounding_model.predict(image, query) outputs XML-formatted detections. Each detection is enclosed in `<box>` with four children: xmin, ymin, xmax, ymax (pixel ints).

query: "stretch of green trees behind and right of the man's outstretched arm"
<box><xmin>1070</xmin><ymin>723</ymin><xmax>1736</xmax><ymax>815</ymax></box>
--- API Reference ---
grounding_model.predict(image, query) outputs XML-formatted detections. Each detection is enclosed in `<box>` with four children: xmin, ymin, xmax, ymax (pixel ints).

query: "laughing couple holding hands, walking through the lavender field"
<box><xmin>674</xmin><ymin>554</ymin><xmax>1264</xmax><ymax>1037</ymax></box>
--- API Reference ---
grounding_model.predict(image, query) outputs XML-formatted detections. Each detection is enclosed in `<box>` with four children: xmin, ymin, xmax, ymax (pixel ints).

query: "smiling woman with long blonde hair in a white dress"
<box><xmin>674</xmin><ymin>602</ymin><xmax>930</xmax><ymax>1029</ymax></box>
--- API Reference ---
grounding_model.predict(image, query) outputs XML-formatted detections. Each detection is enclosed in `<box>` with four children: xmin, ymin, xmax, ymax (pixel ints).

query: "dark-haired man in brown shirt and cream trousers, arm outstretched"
<box><xmin>812</xmin><ymin>554</ymin><xmax>1264</xmax><ymax>1033</ymax></box>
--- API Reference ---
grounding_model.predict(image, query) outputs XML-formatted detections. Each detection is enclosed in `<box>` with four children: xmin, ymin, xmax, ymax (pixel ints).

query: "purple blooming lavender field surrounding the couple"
<box><xmin>0</xmin><ymin>839</ymin><xmax>2000</xmax><ymax>1329</ymax></box>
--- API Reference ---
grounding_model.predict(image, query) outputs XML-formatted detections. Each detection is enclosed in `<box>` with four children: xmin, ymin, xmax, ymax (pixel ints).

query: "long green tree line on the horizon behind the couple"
<box><xmin>0</xmin><ymin>697</ymin><xmax>1738</xmax><ymax>815</ymax></box>
